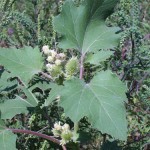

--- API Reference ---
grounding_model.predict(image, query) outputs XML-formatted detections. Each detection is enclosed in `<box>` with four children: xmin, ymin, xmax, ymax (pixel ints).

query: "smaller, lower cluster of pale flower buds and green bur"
<box><xmin>52</xmin><ymin>122</ymin><xmax>74</xmax><ymax>145</ymax></box>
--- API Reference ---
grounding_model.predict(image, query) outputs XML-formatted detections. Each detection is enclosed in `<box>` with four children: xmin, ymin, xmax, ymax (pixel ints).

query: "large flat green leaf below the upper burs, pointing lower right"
<box><xmin>60</xmin><ymin>71</ymin><xmax>127</xmax><ymax>140</ymax></box>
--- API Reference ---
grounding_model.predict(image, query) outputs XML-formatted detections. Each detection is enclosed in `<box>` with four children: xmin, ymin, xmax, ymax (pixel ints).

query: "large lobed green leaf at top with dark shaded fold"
<box><xmin>54</xmin><ymin>0</ymin><xmax>120</xmax><ymax>54</ymax></box>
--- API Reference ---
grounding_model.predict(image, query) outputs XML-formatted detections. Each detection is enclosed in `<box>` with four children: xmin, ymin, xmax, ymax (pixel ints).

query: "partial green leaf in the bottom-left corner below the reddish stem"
<box><xmin>0</xmin><ymin>120</ymin><xmax>17</xmax><ymax>150</ymax></box>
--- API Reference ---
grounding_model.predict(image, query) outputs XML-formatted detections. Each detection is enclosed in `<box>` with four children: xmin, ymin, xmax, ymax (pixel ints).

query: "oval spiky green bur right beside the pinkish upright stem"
<box><xmin>65</xmin><ymin>57</ymin><xmax>79</xmax><ymax>76</ymax></box>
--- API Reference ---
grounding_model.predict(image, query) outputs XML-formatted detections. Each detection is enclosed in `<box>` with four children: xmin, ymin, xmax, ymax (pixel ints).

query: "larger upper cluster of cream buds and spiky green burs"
<box><xmin>42</xmin><ymin>45</ymin><xmax>79</xmax><ymax>79</ymax></box>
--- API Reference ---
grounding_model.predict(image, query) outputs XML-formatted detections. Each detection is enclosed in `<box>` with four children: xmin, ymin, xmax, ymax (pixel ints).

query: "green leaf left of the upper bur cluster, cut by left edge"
<box><xmin>0</xmin><ymin>47</ymin><xmax>43</xmax><ymax>83</ymax></box>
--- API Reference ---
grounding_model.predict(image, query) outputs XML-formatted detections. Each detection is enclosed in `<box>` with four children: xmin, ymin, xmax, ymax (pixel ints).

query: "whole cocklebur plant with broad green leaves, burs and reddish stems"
<box><xmin>0</xmin><ymin>0</ymin><xmax>127</xmax><ymax>150</ymax></box>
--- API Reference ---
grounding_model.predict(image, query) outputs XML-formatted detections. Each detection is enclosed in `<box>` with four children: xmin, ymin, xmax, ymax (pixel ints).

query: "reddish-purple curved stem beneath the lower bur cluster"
<box><xmin>7</xmin><ymin>128</ymin><xmax>67</xmax><ymax>150</ymax></box>
